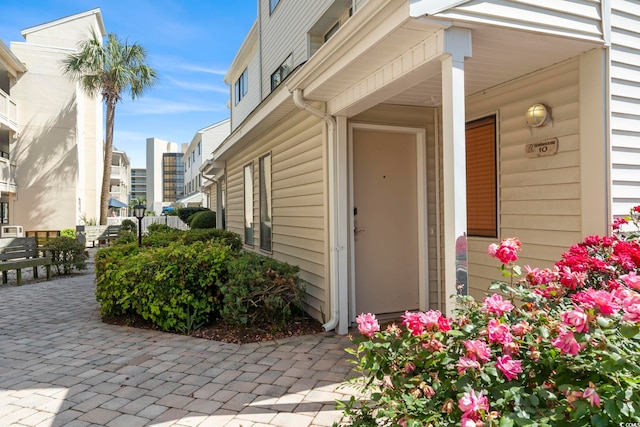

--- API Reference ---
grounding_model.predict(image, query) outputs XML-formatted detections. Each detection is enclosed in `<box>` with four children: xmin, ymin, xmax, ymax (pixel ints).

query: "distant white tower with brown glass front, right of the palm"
<box><xmin>146</xmin><ymin>138</ymin><xmax>187</xmax><ymax>214</ymax></box>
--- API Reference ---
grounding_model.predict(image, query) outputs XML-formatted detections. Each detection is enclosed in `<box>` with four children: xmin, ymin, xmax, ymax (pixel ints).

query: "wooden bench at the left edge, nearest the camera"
<box><xmin>0</xmin><ymin>237</ymin><xmax>51</xmax><ymax>285</ymax></box>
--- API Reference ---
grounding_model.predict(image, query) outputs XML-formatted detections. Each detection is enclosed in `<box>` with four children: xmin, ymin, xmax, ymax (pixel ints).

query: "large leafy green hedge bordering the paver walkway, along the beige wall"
<box><xmin>96</xmin><ymin>229</ymin><xmax>304</xmax><ymax>332</ymax></box>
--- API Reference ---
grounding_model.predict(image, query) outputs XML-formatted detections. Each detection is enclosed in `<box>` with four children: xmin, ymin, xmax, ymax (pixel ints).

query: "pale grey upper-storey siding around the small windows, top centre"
<box><xmin>260</xmin><ymin>0</ymin><xmax>332</xmax><ymax>99</ymax></box>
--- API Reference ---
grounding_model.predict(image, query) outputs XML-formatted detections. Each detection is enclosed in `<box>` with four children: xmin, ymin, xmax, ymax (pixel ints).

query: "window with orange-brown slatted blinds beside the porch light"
<box><xmin>466</xmin><ymin>116</ymin><xmax>498</xmax><ymax>237</ymax></box>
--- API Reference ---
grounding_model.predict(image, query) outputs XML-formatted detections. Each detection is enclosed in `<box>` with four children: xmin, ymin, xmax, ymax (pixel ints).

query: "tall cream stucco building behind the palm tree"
<box><xmin>0</xmin><ymin>9</ymin><xmax>106</xmax><ymax>230</ymax></box>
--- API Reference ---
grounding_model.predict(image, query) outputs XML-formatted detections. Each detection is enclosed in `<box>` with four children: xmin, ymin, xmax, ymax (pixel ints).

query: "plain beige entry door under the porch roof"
<box><xmin>353</xmin><ymin>129</ymin><xmax>420</xmax><ymax>315</ymax></box>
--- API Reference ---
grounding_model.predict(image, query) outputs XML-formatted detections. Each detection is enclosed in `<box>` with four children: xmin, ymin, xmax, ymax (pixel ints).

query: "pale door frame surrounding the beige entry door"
<box><xmin>348</xmin><ymin>123</ymin><xmax>429</xmax><ymax>322</ymax></box>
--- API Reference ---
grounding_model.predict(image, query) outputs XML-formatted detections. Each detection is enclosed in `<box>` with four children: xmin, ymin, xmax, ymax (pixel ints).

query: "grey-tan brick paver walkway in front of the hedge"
<box><xmin>0</xmin><ymin>258</ymin><xmax>354</xmax><ymax>427</ymax></box>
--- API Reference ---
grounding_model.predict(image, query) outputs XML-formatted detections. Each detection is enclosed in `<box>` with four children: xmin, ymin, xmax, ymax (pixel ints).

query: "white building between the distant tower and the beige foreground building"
<box><xmin>178</xmin><ymin>119</ymin><xmax>231</xmax><ymax>211</ymax></box>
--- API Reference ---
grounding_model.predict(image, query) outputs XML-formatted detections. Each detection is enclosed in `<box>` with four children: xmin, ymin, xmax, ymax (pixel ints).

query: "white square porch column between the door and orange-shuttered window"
<box><xmin>442</xmin><ymin>28</ymin><xmax>471</xmax><ymax>315</ymax></box>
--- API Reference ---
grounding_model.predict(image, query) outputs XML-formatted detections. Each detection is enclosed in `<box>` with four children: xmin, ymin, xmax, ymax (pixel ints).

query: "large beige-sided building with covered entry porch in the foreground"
<box><xmin>212</xmin><ymin>0</ymin><xmax>640</xmax><ymax>332</ymax></box>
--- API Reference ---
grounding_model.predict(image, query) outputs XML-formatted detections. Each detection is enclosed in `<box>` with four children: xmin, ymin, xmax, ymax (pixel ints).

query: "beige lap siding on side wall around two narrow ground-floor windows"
<box><xmin>226</xmin><ymin>110</ymin><xmax>331</xmax><ymax>319</ymax></box>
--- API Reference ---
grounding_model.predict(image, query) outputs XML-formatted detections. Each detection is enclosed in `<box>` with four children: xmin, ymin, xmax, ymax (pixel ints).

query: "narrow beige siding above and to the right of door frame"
<box><xmin>350</xmin><ymin>104</ymin><xmax>444</xmax><ymax>309</ymax></box>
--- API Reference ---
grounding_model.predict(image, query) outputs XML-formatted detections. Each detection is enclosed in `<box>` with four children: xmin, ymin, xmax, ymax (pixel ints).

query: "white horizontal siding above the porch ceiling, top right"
<box><xmin>436</xmin><ymin>0</ymin><xmax>603</xmax><ymax>40</ymax></box>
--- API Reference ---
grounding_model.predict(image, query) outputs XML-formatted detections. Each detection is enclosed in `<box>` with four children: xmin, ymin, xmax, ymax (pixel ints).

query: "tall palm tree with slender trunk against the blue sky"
<box><xmin>62</xmin><ymin>31</ymin><xmax>157</xmax><ymax>225</ymax></box>
